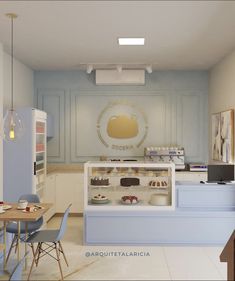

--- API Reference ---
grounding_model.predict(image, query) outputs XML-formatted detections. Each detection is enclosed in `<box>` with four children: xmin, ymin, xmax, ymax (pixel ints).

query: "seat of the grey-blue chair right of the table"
<box><xmin>26</xmin><ymin>229</ymin><xmax>60</xmax><ymax>243</ymax></box>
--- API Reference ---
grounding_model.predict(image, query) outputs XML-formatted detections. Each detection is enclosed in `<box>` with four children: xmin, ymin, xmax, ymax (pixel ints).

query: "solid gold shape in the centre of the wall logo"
<box><xmin>107</xmin><ymin>114</ymin><xmax>139</xmax><ymax>139</ymax></box>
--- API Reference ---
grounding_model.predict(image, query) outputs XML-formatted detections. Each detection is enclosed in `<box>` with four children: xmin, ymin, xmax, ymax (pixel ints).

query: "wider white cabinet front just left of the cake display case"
<box><xmin>56</xmin><ymin>173</ymin><xmax>83</xmax><ymax>213</ymax></box>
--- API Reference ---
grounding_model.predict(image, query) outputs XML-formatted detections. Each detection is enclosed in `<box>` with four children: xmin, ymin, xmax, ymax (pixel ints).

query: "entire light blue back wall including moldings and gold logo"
<box><xmin>35</xmin><ymin>71</ymin><xmax>208</xmax><ymax>163</ymax></box>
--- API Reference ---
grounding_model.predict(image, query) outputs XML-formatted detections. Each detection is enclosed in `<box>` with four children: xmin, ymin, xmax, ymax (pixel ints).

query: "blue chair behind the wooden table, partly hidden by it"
<box><xmin>6</xmin><ymin>194</ymin><xmax>43</xmax><ymax>264</ymax></box>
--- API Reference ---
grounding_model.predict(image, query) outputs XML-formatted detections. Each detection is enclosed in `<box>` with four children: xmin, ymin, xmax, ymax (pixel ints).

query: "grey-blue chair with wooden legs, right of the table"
<box><xmin>26</xmin><ymin>204</ymin><xmax>72</xmax><ymax>280</ymax></box>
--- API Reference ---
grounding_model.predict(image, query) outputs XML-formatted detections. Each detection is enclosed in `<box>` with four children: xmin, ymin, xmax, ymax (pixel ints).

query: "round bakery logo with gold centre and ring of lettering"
<box><xmin>96</xmin><ymin>100</ymin><xmax>148</xmax><ymax>151</ymax></box>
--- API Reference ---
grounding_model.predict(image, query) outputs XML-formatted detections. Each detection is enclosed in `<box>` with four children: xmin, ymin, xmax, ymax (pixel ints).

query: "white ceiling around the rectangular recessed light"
<box><xmin>0</xmin><ymin>1</ymin><xmax>235</xmax><ymax>70</ymax></box>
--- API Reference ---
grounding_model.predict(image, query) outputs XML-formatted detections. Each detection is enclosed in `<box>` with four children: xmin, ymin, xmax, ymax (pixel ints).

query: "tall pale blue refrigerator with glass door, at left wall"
<box><xmin>3</xmin><ymin>108</ymin><xmax>47</xmax><ymax>202</ymax></box>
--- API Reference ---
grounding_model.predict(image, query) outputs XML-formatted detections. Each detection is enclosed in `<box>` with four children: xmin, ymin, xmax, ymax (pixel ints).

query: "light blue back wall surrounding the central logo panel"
<box><xmin>34</xmin><ymin>71</ymin><xmax>208</xmax><ymax>163</ymax></box>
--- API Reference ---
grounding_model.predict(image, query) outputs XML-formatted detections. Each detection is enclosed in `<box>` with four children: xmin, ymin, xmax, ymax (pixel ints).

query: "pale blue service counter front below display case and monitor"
<box><xmin>84</xmin><ymin>182</ymin><xmax>235</xmax><ymax>245</ymax></box>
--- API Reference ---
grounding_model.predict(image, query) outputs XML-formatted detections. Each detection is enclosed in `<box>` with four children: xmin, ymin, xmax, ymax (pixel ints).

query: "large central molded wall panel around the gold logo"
<box><xmin>71</xmin><ymin>91</ymin><xmax>170</xmax><ymax>162</ymax></box>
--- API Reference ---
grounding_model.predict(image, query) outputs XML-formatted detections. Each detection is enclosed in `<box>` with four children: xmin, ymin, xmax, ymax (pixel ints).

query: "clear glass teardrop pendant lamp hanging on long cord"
<box><xmin>3</xmin><ymin>13</ymin><xmax>23</xmax><ymax>142</ymax></box>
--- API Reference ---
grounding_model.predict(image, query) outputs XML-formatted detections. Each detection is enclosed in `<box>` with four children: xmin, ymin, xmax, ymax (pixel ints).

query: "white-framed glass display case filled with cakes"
<box><xmin>84</xmin><ymin>161</ymin><xmax>175</xmax><ymax>210</ymax></box>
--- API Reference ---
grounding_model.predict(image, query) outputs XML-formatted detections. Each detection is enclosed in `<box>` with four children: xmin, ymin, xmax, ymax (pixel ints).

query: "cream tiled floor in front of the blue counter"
<box><xmin>9</xmin><ymin>218</ymin><xmax>226</xmax><ymax>280</ymax></box>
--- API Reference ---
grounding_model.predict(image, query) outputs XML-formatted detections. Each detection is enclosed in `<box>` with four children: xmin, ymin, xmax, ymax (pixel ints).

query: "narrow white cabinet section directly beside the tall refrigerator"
<box><xmin>44</xmin><ymin>174</ymin><xmax>56</xmax><ymax>222</ymax></box>
